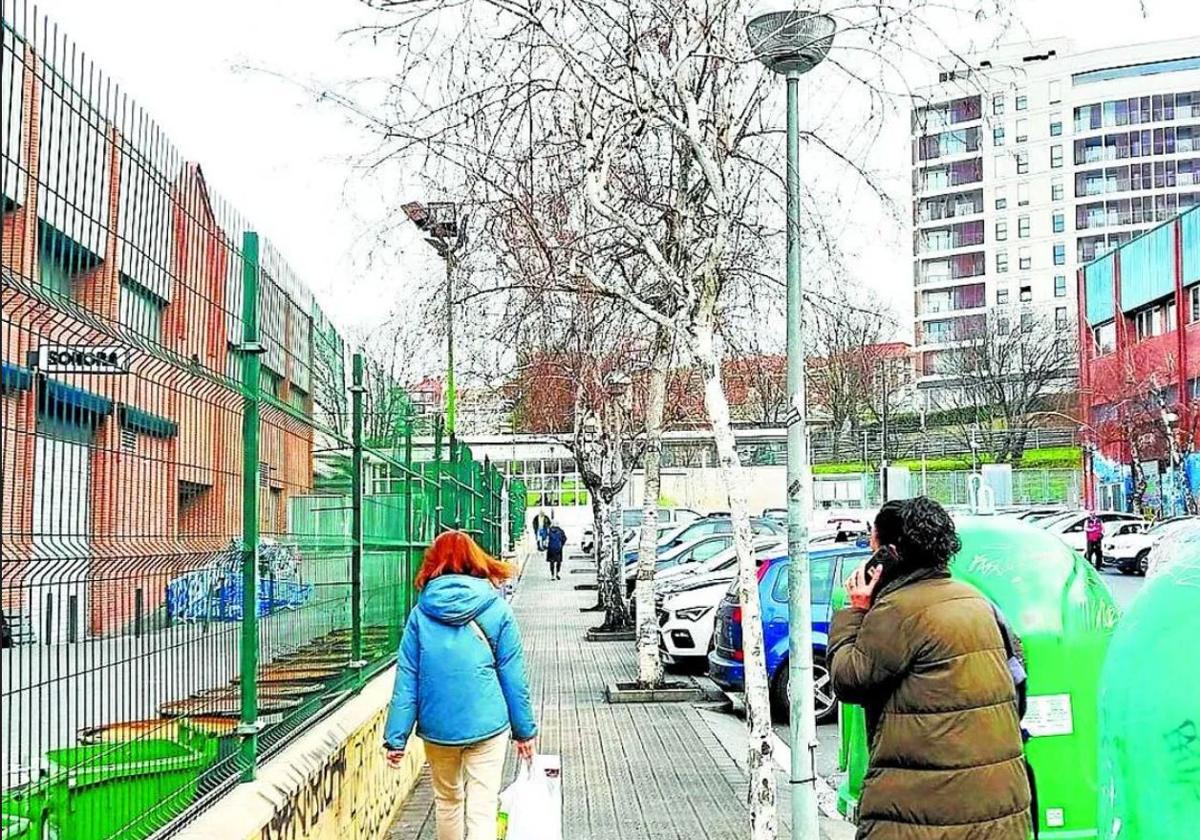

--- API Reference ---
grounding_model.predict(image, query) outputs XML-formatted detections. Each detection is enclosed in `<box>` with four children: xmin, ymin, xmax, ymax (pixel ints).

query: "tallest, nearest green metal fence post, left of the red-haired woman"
<box><xmin>238</xmin><ymin>230</ymin><xmax>263</xmax><ymax>781</ymax></box>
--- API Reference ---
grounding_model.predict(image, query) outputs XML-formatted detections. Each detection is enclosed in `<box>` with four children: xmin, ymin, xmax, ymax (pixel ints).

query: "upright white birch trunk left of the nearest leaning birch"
<box><xmin>634</xmin><ymin>325</ymin><xmax>671</xmax><ymax>689</ymax></box>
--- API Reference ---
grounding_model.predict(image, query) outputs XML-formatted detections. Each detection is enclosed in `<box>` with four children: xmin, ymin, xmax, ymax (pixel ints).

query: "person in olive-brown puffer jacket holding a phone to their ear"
<box><xmin>829</xmin><ymin>498</ymin><xmax>1032</xmax><ymax>840</ymax></box>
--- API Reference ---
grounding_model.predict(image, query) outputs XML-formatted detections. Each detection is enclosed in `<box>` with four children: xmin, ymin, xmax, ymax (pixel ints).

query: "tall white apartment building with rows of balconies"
<box><xmin>912</xmin><ymin>37</ymin><xmax>1200</xmax><ymax>391</ymax></box>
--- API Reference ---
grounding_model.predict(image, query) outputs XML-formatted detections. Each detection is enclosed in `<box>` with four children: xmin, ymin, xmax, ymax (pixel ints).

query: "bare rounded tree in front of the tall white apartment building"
<box><xmin>918</xmin><ymin>307</ymin><xmax>1078</xmax><ymax>463</ymax></box>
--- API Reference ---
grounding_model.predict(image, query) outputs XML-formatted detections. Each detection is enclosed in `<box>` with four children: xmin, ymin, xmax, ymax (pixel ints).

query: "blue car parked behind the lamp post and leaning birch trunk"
<box><xmin>708</xmin><ymin>546</ymin><xmax>870</xmax><ymax>724</ymax></box>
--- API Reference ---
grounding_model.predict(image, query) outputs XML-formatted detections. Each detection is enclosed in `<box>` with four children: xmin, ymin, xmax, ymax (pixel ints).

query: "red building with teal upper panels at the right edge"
<box><xmin>1078</xmin><ymin>209</ymin><xmax>1200</xmax><ymax>514</ymax></box>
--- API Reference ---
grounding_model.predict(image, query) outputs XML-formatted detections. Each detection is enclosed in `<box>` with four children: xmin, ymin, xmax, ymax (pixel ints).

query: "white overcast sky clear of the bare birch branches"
<box><xmin>23</xmin><ymin>0</ymin><xmax>1200</xmax><ymax>355</ymax></box>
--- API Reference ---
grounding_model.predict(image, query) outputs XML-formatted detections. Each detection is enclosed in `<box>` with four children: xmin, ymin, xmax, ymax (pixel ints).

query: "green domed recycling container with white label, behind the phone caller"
<box><xmin>835</xmin><ymin>516</ymin><xmax>1123</xmax><ymax>840</ymax></box>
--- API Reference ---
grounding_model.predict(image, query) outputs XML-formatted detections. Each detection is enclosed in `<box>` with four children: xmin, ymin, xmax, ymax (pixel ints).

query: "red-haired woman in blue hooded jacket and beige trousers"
<box><xmin>384</xmin><ymin>530</ymin><xmax>538</xmax><ymax>840</ymax></box>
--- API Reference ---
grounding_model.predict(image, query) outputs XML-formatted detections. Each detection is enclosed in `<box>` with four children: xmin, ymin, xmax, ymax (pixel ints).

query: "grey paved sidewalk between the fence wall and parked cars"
<box><xmin>389</xmin><ymin>557</ymin><xmax>758</xmax><ymax>840</ymax></box>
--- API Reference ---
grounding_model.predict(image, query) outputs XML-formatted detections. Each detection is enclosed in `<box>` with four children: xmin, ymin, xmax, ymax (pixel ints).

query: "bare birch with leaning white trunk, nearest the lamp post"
<box><xmin>326</xmin><ymin>0</ymin><xmax>1022</xmax><ymax>839</ymax></box>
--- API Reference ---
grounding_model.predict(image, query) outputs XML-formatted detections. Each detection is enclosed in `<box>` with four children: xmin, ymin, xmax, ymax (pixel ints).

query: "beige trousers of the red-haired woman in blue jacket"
<box><xmin>425</xmin><ymin>732</ymin><xmax>509</xmax><ymax>840</ymax></box>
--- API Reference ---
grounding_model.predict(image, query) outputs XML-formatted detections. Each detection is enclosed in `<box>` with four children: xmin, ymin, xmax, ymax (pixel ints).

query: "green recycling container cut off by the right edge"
<box><xmin>1099</xmin><ymin>548</ymin><xmax>1200</xmax><ymax>840</ymax></box>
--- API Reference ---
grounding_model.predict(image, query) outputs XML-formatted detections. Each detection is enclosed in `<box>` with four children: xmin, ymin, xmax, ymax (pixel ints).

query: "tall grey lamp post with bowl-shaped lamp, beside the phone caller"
<box><xmin>746</xmin><ymin>6</ymin><xmax>836</xmax><ymax>840</ymax></box>
